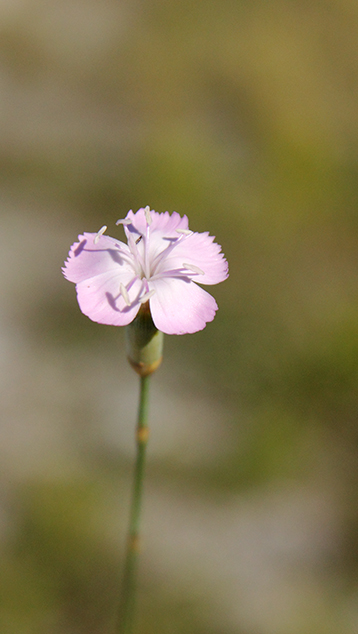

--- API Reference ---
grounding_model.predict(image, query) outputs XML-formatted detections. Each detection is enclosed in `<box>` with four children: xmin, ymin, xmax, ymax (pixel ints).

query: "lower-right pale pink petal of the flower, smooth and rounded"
<box><xmin>149</xmin><ymin>277</ymin><xmax>218</xmax><ymax>335</ymax></box>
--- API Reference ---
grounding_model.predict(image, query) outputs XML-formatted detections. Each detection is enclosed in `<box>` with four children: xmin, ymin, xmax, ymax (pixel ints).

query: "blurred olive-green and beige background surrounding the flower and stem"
<box><xmin>0</xmin><ymin>0</ymin><xmax>358</xmax><ymax>634</ymax></box>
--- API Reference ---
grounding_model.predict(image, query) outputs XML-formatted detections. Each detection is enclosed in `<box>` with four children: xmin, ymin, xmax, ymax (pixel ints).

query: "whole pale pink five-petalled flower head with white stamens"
<box><xmin>62</xmin><ymin>207</ymin><xmax>228</xmax><ymax>335</ymax></box>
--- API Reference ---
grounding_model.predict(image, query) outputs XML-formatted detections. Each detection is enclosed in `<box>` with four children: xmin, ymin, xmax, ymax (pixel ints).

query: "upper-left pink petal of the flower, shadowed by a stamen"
<box><xmin>62</xmin><ymin>233</ymin><xmax>134</xmax><ymax>283</ymax></box>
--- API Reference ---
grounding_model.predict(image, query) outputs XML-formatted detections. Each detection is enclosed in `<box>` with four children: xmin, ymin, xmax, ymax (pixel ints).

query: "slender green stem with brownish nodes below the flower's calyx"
<box><xmin>117</xmin><ymin>375</ymin><xmax>149</xmax><ymax>634</ymax></box>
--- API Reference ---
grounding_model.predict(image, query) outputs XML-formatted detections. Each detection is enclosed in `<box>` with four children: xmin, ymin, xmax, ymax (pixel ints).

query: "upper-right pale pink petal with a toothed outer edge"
<box><xmin>155</xmin><ymin>232</ymin><xmax>229</xmax><ymax>284</ymax></box>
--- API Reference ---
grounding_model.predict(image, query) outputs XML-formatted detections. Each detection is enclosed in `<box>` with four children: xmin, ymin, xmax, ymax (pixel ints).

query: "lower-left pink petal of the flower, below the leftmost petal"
<box><xmin>76</xmin><ymin>269</ymin><xmax>143</xmax><ymax>326</ymax></box>
